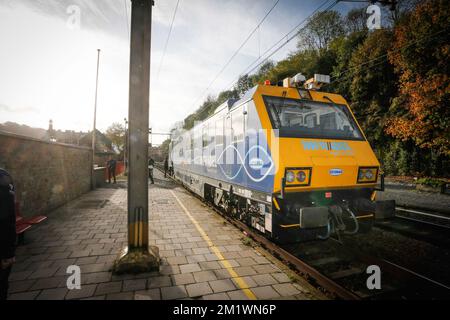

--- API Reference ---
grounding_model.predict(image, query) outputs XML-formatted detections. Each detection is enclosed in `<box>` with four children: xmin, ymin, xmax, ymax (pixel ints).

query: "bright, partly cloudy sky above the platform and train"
<box><xmin>0</xmin><ymin>0</ymin><xmax>361</xmax><ymax>144</ymax></box>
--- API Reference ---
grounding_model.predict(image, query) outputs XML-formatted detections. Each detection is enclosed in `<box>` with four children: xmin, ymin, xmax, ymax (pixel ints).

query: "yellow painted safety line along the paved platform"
<box><xmin>170</xmin><ymin>190</ymin><xmax>256</xmax><ymax>300</ymax></box>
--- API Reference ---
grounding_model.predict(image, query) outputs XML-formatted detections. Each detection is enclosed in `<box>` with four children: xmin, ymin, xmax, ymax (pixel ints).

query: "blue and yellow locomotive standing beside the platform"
<box><xmin>170</xmin><ymin>74</ymin><xmax>379</xmax><ymax>242</ymax></box>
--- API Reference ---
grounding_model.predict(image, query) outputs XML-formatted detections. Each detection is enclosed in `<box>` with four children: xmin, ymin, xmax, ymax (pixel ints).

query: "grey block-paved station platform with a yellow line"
<box><xmin>8</xmin><ymin>170</ymin><xmax>325</xmax><ymax>300</ymax></box>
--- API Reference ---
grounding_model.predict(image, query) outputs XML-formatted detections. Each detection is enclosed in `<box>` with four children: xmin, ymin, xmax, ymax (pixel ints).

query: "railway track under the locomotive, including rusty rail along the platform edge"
<box><xmin>156</xmin><ymin>166</ymin><xmax>450</xmax><ymax>300</ymax></box>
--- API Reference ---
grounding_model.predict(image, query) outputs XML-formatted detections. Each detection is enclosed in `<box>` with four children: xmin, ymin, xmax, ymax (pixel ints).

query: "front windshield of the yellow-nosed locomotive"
<box><xmin>264</xmin><ymin>96</ymin><xmax>364</xmax><ymax>140</ymax></box>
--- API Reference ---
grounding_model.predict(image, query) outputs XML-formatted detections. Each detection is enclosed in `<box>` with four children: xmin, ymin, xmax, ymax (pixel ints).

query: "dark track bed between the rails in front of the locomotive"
<box><xmin>285</xmin><ymin>237</ymin><xmax>450</xmax><ymax>300</ymax></box>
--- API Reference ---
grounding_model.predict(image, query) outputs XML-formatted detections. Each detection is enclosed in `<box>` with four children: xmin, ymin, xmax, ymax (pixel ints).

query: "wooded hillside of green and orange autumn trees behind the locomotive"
<box><xmin>180</xmin><ymin>0</ymin><xmax>450</xmax><ymax>177</ymax></box>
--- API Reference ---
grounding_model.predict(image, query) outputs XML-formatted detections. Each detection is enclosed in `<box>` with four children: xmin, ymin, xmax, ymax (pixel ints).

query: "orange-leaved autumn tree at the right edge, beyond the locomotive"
<box><xmin>386</xmin><ymin>0</ymin><xmax>450</xmax><ymax>157</ymax></box>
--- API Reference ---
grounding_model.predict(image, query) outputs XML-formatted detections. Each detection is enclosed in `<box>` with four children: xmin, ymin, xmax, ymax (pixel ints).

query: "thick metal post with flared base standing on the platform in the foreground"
<box><xmin>114</xmin><ymin>0</ymin><xmax>160</xmax><ymax>273</ymax></box>
